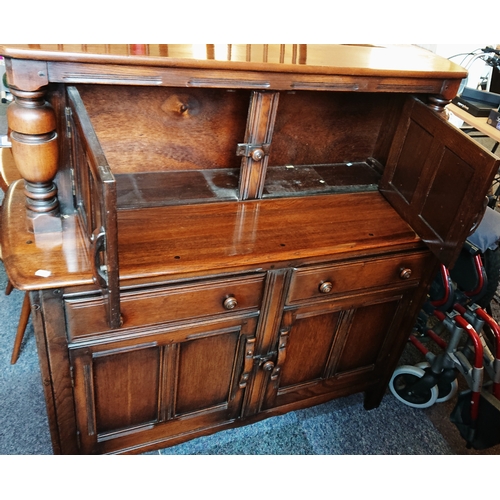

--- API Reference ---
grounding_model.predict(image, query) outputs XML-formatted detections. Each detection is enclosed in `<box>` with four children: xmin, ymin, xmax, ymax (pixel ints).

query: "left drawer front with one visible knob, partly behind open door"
<box><xmin>65</xmin><ymin>274</ymin><xmax>265</xmax><ymax>340</ymax></box>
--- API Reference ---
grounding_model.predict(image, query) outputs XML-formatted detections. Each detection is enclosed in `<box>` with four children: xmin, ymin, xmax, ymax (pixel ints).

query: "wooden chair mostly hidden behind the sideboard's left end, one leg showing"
<box><xmin>0</xmin><ymin>148</ymin><xmax>31</xmax><ymax>364</ymax></box>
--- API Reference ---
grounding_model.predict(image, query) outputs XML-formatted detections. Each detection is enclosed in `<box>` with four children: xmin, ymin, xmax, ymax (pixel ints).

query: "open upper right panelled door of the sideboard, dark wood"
<box><xmin>380</xmin><ymin>98</ymin><xmax>500</xmax><ymax>268</ymax></box>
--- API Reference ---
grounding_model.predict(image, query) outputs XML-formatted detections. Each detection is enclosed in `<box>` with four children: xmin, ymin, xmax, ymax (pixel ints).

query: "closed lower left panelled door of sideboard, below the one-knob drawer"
<box><xmin>70</xmin><ymin>316</ymin><xmax>256</xmax><ymax>453</ymax></box>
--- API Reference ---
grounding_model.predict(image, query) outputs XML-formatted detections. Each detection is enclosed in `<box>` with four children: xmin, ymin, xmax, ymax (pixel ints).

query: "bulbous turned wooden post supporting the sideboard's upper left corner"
<box><xmin>7</xmin><ymin>88</ymin><xmax>61</xmax><ymax>233</ymax></box>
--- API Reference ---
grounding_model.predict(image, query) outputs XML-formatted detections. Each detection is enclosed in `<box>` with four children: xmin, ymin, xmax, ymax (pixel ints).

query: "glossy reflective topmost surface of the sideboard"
<box><xmin>0</xmin><ymin>44</ymin><xmax>467</xmax><ymax>79</ymax></box>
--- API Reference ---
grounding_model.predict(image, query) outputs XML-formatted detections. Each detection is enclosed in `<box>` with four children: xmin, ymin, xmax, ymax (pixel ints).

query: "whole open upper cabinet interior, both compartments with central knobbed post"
<box><xmin>68</xmin><ymin>85</ymin><xmax>400</xmax><ymax>209</ymax></box>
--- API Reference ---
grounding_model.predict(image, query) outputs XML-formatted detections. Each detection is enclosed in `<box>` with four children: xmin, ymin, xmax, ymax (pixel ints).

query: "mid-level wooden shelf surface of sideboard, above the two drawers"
<box><xmin>2</xmin><ymin>182</ymin><xmax>423</xmax><ymax>290</ymax></box>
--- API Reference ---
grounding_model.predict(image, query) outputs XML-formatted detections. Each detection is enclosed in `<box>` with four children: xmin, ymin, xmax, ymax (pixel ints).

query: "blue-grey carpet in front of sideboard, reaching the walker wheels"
<box><xmin>160</xmin><ymin>394</ymin><xmax>453</xmax><ymax>455</ymax></box>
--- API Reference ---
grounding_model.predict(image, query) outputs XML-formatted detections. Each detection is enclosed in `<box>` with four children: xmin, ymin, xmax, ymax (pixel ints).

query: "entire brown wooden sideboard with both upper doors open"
<box><xmin>0</xmin><ymin>45</ymin><xmax>498</xmax><ymax>454</ymax></box>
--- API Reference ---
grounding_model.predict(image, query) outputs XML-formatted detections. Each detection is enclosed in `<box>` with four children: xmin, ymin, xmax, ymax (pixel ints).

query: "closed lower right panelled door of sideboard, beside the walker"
<box><xmin>262</xmin><ymin>288</ymin><xmax>415</xmax><ymax>409</ymax></box>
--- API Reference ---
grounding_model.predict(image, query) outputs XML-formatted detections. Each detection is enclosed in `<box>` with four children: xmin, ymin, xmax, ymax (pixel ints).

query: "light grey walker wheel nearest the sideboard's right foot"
<box><xmin>389</xmin><ymin>365</ymin><xmax>439</xmax><ymax>408</ymax></box>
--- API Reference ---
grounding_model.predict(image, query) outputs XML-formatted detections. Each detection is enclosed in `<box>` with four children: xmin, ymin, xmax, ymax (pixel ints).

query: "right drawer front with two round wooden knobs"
<box><xmin>287</xmin><ymin>252</ymin><xmax>433</xmax><ymax>304</ymax></box>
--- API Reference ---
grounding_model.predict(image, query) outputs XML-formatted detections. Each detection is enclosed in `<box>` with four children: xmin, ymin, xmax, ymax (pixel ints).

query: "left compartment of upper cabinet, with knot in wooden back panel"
<box><xmin>73</xmin><ymin>85</ymin><xmax>250</xmax><ymax>208</ymax></box>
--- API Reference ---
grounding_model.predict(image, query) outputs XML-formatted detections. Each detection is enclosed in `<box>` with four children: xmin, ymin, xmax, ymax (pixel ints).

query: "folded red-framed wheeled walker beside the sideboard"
<box><xmin>389</xmin><ymin>207</ymin><xmax>500</xmax><ymax>450</ymax></box>
